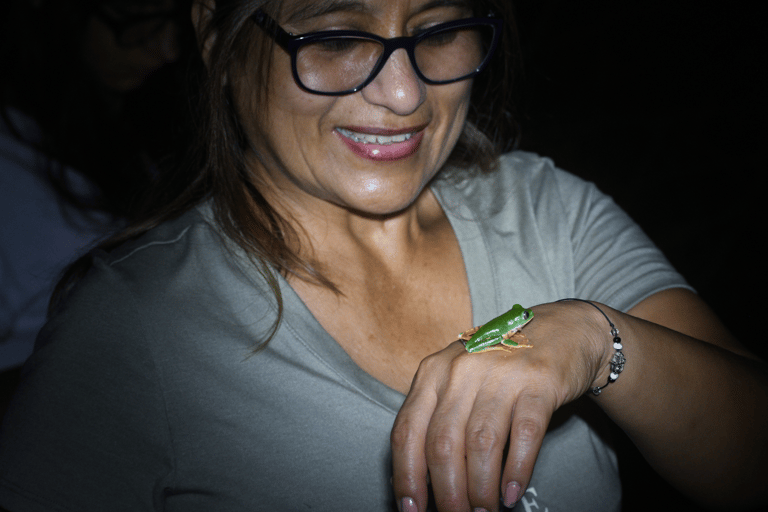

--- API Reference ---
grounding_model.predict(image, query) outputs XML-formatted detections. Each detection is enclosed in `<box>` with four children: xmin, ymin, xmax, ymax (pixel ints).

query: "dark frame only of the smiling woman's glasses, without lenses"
<box><xmin>251</xmin><ymin>8</ymin><xmax>504</xmax><ymax>96</ymax></box>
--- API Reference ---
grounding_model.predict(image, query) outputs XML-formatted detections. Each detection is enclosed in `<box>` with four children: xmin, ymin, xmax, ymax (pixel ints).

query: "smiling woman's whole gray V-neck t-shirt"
<box><xmin>0</xmin><ymin>153</ymin><xmax>687</xmax><ymax>512</ymax></box>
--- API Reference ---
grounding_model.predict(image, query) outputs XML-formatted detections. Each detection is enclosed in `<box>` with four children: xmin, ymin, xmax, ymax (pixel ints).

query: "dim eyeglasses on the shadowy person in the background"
<box><xmin>93</xmin><ymin>4</ymin><xmax>179</xmax><ymax>48</ymax></box>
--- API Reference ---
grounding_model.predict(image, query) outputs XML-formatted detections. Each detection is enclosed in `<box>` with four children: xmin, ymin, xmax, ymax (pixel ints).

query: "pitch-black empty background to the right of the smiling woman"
<box><xmin>514</xmin><ymin>0</ymin><xmax>768</xmax><ymax>511</ymax></box>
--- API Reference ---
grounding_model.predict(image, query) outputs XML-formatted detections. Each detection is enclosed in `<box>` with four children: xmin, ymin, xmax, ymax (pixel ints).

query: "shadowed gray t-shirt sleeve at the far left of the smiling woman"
<box><xmin>0</xmin><ymin>260</ymin><xmax>173</xmax><ymax>512</ymax></box>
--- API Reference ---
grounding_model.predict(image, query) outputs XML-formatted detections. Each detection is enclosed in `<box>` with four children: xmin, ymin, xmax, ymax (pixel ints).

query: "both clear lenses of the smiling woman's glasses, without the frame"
<box><xmin>296</xmin><ymin>25</ymin><xmax>493</xmax><ymax>93</ymax></box>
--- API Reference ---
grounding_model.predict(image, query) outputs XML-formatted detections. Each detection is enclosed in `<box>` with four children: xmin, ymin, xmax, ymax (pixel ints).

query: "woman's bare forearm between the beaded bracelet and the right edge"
<box><xmin>595</xmin><ymin>304</ymin><xmax>768</xmax><ymax>508</ymax></box>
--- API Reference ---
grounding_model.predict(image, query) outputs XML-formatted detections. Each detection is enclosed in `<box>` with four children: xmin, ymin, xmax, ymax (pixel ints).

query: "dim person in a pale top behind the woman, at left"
<box><xmin>0</xmin><ymin>0</ymin><xmax>189</xmax><ymax>392</ymax></box>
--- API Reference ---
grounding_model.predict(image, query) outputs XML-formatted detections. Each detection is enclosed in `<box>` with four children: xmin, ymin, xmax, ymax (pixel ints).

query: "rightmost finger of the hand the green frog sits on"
<box><xmin>501</xmin><ymin>391</ymin><xmax>555</xmax><ymax>507</ymax></box>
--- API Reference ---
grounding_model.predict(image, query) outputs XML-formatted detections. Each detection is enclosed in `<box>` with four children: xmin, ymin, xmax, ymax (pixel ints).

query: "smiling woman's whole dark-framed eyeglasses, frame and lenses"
<box><xmin>251</xmin><ymin>9</ymin><xmax>502</xmax><ymax>96</ymax></box>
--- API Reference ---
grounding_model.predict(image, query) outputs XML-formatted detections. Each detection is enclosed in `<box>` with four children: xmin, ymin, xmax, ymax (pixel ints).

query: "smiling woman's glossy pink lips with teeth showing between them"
<box><xmin>336</xmin><ymin>125</ymin><xmax>426</xmax><ymax>161</ymax></box>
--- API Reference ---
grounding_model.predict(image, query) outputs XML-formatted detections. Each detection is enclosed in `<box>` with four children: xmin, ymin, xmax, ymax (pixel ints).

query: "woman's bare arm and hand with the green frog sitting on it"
<box><xmin>392</xmin><ymin>290</ymin><xmax>768</xmax><ymax>511</ymax></box>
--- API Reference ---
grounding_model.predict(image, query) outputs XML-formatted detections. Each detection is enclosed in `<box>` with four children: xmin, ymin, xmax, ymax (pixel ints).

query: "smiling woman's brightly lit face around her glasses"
<box><xmin>236</xmin><ymin>0</ymin><xmax>472</xmax><ymax>215</ymax></box>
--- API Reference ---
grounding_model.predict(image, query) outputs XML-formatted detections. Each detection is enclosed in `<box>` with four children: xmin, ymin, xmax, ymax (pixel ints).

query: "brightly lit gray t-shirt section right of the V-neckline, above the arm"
<box><xmin>438</xmin><ymin>151</ymin><xmax>690</xmax><ymax>316</ymax></box>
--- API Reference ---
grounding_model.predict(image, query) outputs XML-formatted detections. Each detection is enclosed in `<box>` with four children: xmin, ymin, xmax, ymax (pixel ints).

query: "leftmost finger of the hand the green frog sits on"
<box><xmin>390</xmin><ymin>374</ymin><xmax>437</xmax><ymax>512</ymax></box>
